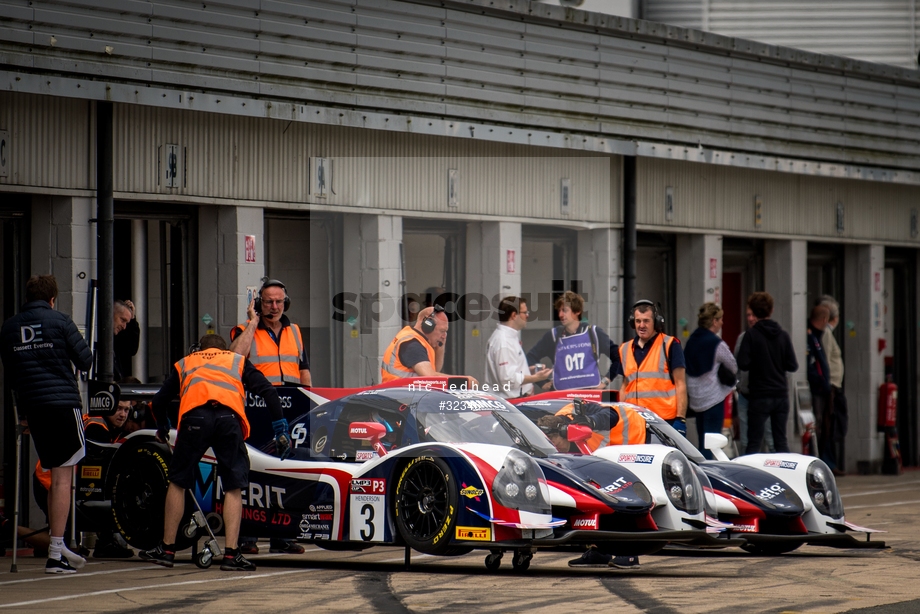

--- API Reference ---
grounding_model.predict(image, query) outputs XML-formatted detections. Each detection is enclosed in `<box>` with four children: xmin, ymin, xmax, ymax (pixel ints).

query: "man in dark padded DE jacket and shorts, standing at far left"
<box><xmin>0</xmin><ymin>275</ymin><xmax>93</xmax><ymax>574</ymax></box>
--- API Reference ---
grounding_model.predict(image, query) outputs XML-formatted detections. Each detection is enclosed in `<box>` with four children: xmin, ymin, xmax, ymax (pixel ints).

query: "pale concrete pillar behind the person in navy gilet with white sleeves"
<box><xmin>668</xmin><ymin>235</ymin><xmax>722</xmax><ymax>343</ymax></box>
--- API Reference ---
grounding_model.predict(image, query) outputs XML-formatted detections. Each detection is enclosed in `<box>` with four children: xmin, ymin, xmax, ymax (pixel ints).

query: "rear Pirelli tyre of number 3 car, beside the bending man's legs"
<box><xmin>108</xmin><ymin>441</ymin><xmax>197</xmax><ymax>550</ymax></box>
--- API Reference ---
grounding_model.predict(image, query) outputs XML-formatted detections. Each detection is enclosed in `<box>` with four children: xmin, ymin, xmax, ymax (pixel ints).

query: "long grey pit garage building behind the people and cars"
<box><xmin>0</xmin><ymin>0</ymin><xmax>920</xmax><ymax>482</ymax></box>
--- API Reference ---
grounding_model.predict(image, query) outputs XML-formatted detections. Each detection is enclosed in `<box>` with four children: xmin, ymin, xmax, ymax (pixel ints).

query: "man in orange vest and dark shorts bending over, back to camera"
<box><xmin>140</xmin><ymin>334</ymin><xmax>291</xmax><ymax>571</ymax></box>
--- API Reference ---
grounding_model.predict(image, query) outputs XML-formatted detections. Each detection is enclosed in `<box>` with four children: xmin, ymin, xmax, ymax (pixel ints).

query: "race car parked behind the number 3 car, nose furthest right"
<box><xmin>515</xmin><ymin>391</ymin><xmax>885</xmax><ymax>555</ymax></box>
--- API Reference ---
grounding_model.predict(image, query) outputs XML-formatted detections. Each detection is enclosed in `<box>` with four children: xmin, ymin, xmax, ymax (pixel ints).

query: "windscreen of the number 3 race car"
<box><xmin>416</xmin><ymin>393</ymin><xmax>556</xmax><ymax>457</ymax></box>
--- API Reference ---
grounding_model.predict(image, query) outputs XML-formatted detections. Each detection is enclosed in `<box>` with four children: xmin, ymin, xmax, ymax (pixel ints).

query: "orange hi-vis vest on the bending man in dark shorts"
<box><xmin>175</xmin><ymin>349</ymin><xmax>249</xmax><ymax>439</ymax></box>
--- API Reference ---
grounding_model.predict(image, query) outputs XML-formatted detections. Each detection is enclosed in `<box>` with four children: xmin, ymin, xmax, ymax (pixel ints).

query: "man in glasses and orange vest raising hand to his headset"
<box><xmin>230</xmin><ymin>279</ymin><xmax>312</xmax><ymax>554</ymax></box>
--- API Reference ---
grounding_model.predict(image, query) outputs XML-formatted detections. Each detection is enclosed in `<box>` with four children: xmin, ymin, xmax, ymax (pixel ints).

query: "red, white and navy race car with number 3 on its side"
<box><xmin>102</xmin><ymin>382</ymin><xmax>722</xmax><ymax>570</ymax></box>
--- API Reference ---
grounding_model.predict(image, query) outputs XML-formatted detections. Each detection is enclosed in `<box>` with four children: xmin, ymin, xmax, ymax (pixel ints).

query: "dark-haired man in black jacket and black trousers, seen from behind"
<box><xmin>738</xmin><ymin>292</ymin><xmax>799</xmax><ymax>454</ymax></box>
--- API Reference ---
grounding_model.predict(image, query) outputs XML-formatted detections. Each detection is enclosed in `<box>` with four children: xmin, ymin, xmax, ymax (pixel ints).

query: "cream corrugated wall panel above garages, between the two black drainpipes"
<box><xmin>115</xmin><ymin>105</ymin><xmax>622</xmax><ymax>223</ymax></box>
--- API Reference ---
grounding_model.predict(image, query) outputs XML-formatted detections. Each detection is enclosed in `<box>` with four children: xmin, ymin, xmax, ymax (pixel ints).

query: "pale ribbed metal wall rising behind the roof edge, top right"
<box><xmin>643</xmin><ymin>0</ymin><xmax>920</xmax><ymax>68</ymax></box>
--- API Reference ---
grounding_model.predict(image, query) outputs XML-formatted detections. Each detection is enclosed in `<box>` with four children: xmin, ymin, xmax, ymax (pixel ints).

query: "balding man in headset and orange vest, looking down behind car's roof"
<box><xmin>380</xmin><ymin>305</ymin><xmax>458</xmax><ymax>384</ymax></box>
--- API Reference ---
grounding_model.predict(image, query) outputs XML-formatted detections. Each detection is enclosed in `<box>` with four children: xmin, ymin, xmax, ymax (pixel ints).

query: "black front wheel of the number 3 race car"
<box><xmin>395</xmin><ymin>456</ymin><xmax>459</xmax><ymax>554</ymax></box>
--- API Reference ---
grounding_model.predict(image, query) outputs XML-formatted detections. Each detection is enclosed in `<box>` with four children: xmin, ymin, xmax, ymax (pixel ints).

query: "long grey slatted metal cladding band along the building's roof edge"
<box><xmin>0</xmin><ymin>0</ymin><xmax>920</xmax><ymax>169</ymax></box>
